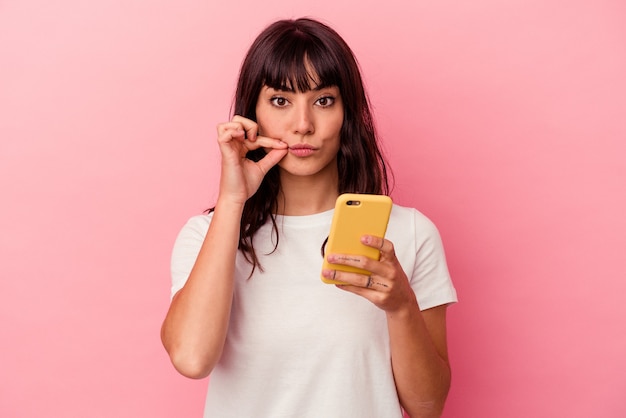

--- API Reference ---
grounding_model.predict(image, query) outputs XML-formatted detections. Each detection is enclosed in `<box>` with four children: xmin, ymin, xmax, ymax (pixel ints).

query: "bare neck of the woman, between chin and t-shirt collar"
<box><xmin>277</xmin><ymin>167</ymin><xmax>339</xmax><ymax>216</ymax></box>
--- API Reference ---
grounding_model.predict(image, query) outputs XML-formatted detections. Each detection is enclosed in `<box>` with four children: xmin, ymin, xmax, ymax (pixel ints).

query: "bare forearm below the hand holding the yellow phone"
<box><xmin>387</xmin><ymin>303</ymin><xmax>450</xmax><ymax>418</ymax></box>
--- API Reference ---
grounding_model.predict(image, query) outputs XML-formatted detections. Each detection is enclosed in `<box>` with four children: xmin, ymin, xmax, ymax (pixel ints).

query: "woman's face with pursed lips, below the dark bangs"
<box><xmin>256</xmin><ymin>86</ymin><xmax>343</xmax><ymax>180</ymax></box>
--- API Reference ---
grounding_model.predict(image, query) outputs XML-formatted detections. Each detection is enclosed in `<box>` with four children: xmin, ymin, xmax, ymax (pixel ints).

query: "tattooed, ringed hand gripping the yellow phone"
<box><xmin>322</xmin><ymin>235</ymin><xmax>417</xmax><ymax>313</ymax></box>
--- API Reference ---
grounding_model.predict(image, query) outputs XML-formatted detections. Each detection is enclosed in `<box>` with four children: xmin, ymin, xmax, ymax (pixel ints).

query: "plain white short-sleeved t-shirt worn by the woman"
<box><xmin>172</xmin><ymin>205</ymin><xmax>457</xmax><ymax>418</ymax></box>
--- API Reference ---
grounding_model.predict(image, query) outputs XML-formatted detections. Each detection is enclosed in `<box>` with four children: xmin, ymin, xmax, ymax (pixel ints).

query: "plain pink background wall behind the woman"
<box><xmin>0</xmin><ymin>0</ymin><xmax>626</xmax><ymax>418</ymax></box>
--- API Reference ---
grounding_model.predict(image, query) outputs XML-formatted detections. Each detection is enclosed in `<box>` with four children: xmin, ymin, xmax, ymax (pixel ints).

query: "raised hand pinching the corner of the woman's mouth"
<box><xmin>217</xmin><ymin>115</ymin><xmax>288</xmax><ymax>205</ymax></box>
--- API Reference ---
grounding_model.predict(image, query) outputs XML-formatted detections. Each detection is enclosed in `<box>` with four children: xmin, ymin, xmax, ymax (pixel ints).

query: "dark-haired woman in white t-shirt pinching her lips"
<box><xmin>162</xmin><ymin>19</ymin><xmax>456</xmax><ymax>418</ymax></box>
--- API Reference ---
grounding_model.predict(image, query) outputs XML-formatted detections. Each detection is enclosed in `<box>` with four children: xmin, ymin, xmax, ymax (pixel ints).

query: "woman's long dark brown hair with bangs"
<box><xmin>216</xmin><ymin>18</ymin><xmax>389</xmax><ymax>271</ymax></box>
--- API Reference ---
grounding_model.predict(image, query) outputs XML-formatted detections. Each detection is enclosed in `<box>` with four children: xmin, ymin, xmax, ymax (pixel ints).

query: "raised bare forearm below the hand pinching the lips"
<box><xmin>161</xmin><ymin>200</ymin><xmax>243</xmax><ymax>378</ymax></box>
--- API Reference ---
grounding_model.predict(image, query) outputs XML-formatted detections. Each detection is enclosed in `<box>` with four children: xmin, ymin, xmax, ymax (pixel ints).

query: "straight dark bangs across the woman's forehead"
<box><xmin>262</xmin><ymin>36</ymin><xmax>342</xmax><ymax>92</ymax></box>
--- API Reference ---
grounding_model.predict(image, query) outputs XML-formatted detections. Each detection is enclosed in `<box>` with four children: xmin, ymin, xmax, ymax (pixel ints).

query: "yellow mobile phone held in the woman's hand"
<box><xmin>322</xmin><ymin>193</ymin><xmax>393</xmax><ymax>284</ymax></box>
